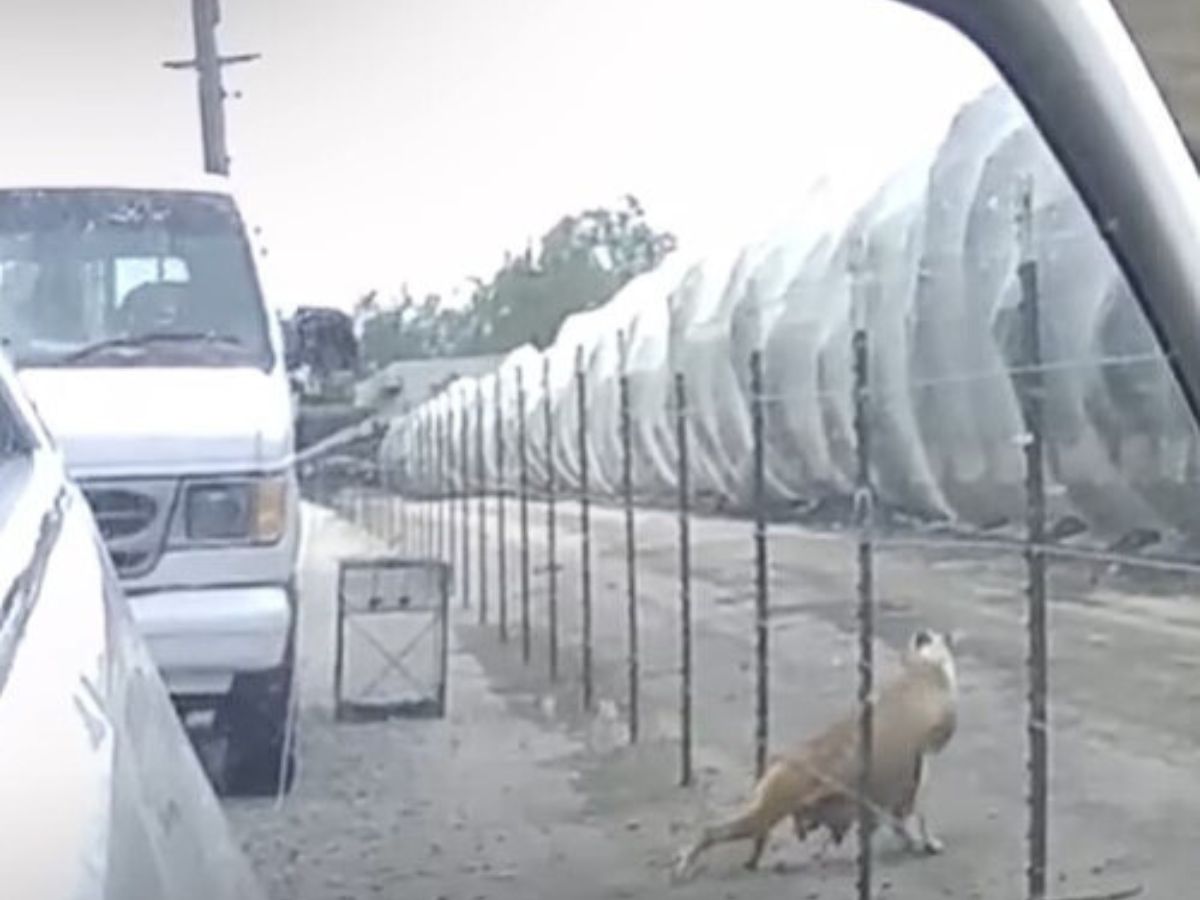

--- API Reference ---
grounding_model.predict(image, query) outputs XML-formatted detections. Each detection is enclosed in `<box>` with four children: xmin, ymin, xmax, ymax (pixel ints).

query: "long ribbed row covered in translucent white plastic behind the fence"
<box><xmin>383</xmin><ymin>84</ymin><xmax>1200</xmax><ymax>549</ymax></box>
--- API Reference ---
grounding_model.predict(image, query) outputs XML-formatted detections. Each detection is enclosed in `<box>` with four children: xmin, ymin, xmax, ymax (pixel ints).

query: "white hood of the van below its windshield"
<box><xmin>18</xmin><ymin>367</ymin><xmax>293</xmax><ymax>478</ymax></box>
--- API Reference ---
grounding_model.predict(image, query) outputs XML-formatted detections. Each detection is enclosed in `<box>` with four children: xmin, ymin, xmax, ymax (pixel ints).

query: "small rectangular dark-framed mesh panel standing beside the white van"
<box><xmin>334</xmin><ymin>557</ymin><xmax>450</xmax><ymax>721</ymax></box>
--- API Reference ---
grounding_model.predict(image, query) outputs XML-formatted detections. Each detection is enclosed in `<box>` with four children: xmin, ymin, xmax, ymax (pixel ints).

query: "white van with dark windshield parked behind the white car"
<box><xmin>0</xmin><ymin>176</ymin><xmax>300</xmax><ymax>793</ymax></box>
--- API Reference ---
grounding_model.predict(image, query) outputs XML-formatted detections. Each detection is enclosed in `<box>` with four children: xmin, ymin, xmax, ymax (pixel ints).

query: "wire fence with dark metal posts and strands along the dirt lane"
<box><xmin>290</xmin><ymin>184</ymin><xmax>1200</xmax><ymax>900</ymax></box>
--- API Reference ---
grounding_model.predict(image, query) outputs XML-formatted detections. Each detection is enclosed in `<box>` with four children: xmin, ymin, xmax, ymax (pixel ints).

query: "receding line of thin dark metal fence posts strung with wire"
<box><xmin>292</xmin><ymin>184</ymin><xmax>1196</xmax><ymax>900</ymax></box>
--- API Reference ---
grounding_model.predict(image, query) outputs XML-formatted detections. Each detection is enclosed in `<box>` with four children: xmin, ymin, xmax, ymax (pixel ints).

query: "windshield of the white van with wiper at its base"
<box><xmin>0</xmin><ymin>188</ymin><xmax>272</xmax><ymax>370</ymax></box>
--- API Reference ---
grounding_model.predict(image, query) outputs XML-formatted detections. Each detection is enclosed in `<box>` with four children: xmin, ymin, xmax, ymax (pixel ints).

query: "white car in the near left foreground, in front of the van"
<box><xmin>0</xmin><ymin>354</ymin><xmax>263</xmax><ymax>900</ymax></box>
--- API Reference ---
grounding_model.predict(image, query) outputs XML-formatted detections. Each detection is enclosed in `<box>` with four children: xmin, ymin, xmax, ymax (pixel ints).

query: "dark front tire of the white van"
<box><xmin>217</xmin><ymin>652</ymin><xmax>295</xmax><ymax>797</ymax></box>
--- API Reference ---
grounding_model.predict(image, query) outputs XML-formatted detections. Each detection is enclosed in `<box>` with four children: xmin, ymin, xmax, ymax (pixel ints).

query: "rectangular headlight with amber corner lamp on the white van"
<box><xmin>182</xmin><ymin>475</ymin><xmax>288</xmax><ymax>544</ymax></box>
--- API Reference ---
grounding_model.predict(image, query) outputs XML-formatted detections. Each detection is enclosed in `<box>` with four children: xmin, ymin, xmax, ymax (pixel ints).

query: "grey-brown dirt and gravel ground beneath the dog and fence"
<box><xmin>228</xmin><ymin>504</ymin><xmax>1200</xmax><ymax>900</ymax></box>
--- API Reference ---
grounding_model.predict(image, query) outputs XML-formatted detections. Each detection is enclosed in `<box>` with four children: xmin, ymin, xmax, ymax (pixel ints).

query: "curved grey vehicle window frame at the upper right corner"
<box><xmin>887</xmin><ymin>0</ymin><xmax>1200</xmax><ymax>424</ymax></box>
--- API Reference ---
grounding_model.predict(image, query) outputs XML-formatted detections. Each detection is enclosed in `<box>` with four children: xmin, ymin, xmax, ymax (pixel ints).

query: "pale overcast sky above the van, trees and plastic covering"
<box><xmin>0</xmin><ymin>0</ymin><xmax>990</xmax><ymax>307</ymax></box>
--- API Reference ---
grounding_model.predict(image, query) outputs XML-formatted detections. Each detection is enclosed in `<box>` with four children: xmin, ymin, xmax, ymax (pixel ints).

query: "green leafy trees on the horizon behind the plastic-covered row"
<box><xmin>355</xmin><ymin>197</ymin><xmax>676</xmax><ymax>368</ymax></box>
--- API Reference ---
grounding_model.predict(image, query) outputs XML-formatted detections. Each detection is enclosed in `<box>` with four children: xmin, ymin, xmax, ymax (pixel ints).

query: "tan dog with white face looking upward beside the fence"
<box><xmin>674</xmin><ymin>629</ymin><xmax>958</xmax><ymax>877</ymax></box>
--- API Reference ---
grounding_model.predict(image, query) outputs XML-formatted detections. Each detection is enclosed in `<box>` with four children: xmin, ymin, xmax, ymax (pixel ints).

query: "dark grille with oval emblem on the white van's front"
<box><xmin>82</xmin><ymin>481</ymin><xmax>176</xmax><ymax>578</ymax></box>
